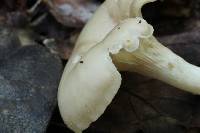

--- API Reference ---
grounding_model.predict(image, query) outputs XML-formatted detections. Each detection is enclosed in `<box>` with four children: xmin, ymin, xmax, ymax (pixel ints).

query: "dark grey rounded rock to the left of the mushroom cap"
<box><xmin>0</xmin><ymin>45</ymin><xmax>62</xmax><ymax>133</ymax></box>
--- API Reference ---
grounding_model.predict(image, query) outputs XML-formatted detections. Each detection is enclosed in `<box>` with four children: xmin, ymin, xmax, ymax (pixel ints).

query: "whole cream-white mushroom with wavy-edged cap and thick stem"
<box><xmin>58</xmin><ymin>0</ymin><xmax>200</xmax><ymax>133</ymax></box>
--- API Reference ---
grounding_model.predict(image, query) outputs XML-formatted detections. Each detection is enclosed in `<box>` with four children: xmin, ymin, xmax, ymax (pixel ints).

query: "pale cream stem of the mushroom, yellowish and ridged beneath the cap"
<box><xmin>113</xmin><ymin>37</ymin><xmax>200</xmax><ymax>94</ymax></box>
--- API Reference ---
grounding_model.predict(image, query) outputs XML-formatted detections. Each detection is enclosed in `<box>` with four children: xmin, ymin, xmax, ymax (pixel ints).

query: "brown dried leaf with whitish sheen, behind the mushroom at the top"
<box><xmin>45</xmin><ymin>0</ymin><xmax>98</xmax><ymax>27</ymax></box>
